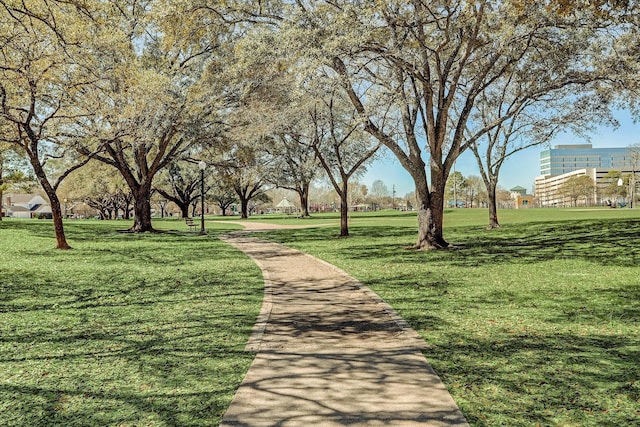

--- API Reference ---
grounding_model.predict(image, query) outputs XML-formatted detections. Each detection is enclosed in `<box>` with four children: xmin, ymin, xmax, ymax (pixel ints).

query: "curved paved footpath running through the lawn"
<box><xmin>220</xmin><ymin>223</ymin><xmax>468</xmax><ymax>427</ymax></box>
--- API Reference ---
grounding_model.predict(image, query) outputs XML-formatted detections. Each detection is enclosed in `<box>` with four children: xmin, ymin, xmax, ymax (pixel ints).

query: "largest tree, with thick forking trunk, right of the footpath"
<box><xmin>283</xmin><ymin>0</ymin><xmax>624</xmax><ymax>249</ymax></box>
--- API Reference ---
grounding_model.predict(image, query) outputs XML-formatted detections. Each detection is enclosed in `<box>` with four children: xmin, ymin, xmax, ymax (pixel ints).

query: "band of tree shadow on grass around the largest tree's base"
<box><xmin>300</xmin><ymin>220</ymin><xmax>640</xmax><ymax>267</ymax></box>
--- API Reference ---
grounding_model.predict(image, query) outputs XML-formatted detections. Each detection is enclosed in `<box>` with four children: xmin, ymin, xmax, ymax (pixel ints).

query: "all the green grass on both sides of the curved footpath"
<box><xmin>0</xmin><ymin>209</ymin><xmax>640</xmax><ymax>426</ymax></box>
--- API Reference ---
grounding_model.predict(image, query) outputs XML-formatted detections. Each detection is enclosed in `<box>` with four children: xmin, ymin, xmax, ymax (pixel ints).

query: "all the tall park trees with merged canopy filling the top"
<box><xmin>0</xmin><ymin>0</ymin><xmax>640</xmax><ymax>249</ymax></box>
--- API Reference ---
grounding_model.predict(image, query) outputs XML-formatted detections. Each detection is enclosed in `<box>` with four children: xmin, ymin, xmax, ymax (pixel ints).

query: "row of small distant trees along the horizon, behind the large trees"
<box><xmin>32</xmin><ymin>166</ymin><xmax>638</xmax><ymax>219</ymax></box>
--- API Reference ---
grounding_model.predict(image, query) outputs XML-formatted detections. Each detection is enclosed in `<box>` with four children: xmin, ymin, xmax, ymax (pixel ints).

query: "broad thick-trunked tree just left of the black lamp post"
<box><xmin>77</xmin><ymin>0</ymin><xmax>225</xmax><ymax>232</ymax></box>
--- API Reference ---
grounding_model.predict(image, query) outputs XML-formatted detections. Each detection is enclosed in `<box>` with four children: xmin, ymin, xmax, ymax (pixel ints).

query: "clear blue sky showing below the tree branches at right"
<box><xmin>360</xmin><ymin>111</ymin><xmax>640</xmax><ymax>197</ymax></box>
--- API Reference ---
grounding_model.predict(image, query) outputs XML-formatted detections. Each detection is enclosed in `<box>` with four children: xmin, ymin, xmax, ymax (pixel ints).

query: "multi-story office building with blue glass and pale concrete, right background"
<box><xmin>535</xmin><ymin>144</ymin><xmax>640</xmax><ymax>207</ymax></box>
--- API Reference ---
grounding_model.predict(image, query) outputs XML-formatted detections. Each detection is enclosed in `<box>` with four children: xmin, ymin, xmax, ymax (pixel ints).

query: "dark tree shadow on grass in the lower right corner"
<box><xmin>425</xmin><ymin>332</ymin><xmax>640</xmax><ymax>426</ymax></box>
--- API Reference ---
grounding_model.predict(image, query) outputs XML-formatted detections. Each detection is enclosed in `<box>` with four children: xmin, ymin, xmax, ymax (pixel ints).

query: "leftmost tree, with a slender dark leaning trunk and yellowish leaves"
<box><xmin>0</xmin><ymin>0</ymin><xmax>98</xmax><ymax>249</ymax></box>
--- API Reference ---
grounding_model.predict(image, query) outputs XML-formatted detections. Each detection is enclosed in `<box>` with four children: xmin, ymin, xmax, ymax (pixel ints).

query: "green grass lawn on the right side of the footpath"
<box><xmin>258</xmin><ymin>209</ymin><xmax>640</xmax><ymax>426</ymax></box>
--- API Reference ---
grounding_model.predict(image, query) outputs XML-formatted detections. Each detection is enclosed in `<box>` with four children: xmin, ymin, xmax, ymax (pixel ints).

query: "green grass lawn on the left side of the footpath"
<box><xmin>0</xmin><ymin>220</ymin><xmax>263</xmax><ymax>427</ymax></box>
